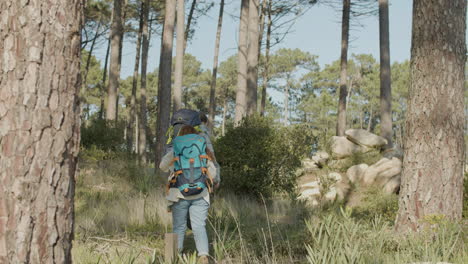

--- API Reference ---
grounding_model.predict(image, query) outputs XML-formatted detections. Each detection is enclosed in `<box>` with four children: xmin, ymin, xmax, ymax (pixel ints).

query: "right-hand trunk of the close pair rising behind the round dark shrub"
<box><xmin>247</xmin><ymin>0</ymin><xmax>259</xmax><ymax>115</ymax></box>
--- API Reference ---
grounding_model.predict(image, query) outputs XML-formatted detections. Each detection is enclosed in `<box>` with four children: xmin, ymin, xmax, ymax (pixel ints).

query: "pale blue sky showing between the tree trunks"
<box><xmin>106</xmin><ymin>0</ymin><xmax>412</xmax><ymax>78</ymax></box>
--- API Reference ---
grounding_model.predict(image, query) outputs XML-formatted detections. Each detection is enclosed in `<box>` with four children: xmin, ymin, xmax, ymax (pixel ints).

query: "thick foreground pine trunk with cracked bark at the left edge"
<box><xmin>0</xmin><ymin>0</ymin><xmax>83</xmax><ymax>263</ymax></box>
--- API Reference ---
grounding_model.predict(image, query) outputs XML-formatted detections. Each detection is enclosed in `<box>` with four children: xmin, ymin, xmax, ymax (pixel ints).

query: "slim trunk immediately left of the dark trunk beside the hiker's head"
<box><xmin>138</xmin><ymin>0</ymin><xmax>150</xmax><ymax>164</ymax></box>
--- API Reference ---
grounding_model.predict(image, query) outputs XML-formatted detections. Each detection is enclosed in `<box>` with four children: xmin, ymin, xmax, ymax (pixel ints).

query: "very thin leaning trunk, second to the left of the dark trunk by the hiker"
<box><xmin>127</xmin><ymin>2</ymin><xmax>145</xmax><ymax>153</ymax></box>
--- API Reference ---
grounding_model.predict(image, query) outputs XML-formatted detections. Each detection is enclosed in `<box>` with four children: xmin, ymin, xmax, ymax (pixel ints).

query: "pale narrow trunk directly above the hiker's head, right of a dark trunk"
<box><xmin>174</xmin><ymin>0</ymin><xmax>185</xmax><ymax>112</ymax></box>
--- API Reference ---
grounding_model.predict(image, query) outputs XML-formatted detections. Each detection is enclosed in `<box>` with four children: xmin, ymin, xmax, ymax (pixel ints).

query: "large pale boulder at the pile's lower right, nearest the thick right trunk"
<box><xmin>361</xmin><ymin>158</ymin><xmax>401</xmax><ymax>186</ymax></box>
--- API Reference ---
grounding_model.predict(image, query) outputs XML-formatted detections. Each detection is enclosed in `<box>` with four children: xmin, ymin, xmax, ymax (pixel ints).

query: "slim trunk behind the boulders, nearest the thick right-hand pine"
<box><xmin>379</xmin><ymin>0</ymin><xmax>393</xmax><ymax>149</ymax></box>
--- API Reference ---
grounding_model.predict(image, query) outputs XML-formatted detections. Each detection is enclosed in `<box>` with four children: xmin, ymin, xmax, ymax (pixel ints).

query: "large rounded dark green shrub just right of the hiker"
<box><xmin>215</xmin><ymin>117</ymin><xmax>312</xmax><ymax>198</ymax></box>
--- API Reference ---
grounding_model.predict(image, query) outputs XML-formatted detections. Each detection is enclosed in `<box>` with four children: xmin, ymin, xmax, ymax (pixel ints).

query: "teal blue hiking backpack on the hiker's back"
<box><xmin>170</xmin><ymin>134</ymin><xmax>212</xmax><ymax>196</ymax></box>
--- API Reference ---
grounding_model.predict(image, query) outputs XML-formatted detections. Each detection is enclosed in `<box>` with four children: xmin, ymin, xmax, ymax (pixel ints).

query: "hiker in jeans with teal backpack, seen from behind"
<box><xmin>159</xmin><ymin>125</ymin><xmax>216</xmax><ymax>264</ymax></box>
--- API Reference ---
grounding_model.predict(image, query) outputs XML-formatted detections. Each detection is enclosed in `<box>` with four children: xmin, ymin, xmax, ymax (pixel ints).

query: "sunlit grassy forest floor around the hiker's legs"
<box><xmin>73</xmin><ymin>160</ymin><xmax>468</xmax><ymax>264</ymax></box>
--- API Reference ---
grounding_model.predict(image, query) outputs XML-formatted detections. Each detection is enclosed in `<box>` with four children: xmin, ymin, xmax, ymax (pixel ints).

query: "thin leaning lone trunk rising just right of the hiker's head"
<box><xmin>208</xmin><ymin>0</ymin><xmax>224</xmax><ymax>131</ymax></box>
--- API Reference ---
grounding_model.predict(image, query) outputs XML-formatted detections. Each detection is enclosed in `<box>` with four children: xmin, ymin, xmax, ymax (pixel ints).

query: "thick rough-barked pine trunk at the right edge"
<box><xmin>396</xmin><ymin>0</ymin><xmax>467</xmax><ymax>231</ymax></box>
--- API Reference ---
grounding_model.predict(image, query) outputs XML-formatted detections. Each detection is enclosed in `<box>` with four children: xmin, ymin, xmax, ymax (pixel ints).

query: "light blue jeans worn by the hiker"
<box><xmin>172</xmin><ymin>198</ymin><xmax>210</xmax><ymax>256</ymax></box>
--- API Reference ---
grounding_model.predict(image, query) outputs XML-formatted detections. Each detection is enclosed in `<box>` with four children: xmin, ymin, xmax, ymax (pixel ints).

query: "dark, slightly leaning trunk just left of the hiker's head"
<box><xmin>155</xmin><ymin>0</ymin><xmax>176</xmax><ymax>168</ymax></box>
